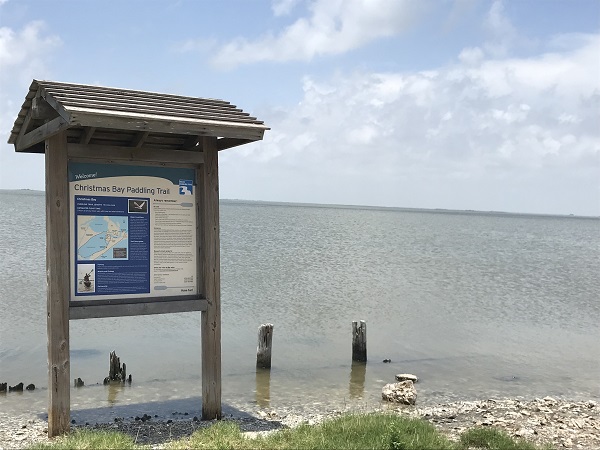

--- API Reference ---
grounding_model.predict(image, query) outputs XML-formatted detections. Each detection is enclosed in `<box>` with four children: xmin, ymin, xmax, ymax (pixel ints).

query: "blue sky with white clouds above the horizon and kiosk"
<box><xmin>0</xmin><ymin>0</ymin><xmax>600</xmax><ymax>216</ymax></box>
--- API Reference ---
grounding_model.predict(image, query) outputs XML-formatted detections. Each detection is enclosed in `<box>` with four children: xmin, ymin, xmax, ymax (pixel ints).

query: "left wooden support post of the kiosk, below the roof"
<box><xmin>45</xmin><ymin>131</ymin><xmax>71</xmax><ymax>437</ymax></box>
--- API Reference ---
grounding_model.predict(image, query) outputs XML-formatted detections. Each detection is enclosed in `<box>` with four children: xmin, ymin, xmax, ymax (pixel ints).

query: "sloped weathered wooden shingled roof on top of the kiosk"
<box><xmin>8</xmin><ymin>80</ymin><xmax>269</xmax><ymax>153</ymax></box>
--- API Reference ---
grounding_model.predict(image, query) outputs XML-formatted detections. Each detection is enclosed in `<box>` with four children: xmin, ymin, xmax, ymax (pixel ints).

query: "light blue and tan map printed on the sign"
<box><xmin>77</xmin><ymin>215</ymin><xmax>129</xmax><ymax>261</ymax></box>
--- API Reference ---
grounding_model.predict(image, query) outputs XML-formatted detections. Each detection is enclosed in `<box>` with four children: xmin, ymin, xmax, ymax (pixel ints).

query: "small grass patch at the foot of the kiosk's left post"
<box><xmin>30</xmin><ymin>430</ymin><xmax>140</xmax><ymax>450</ymax></box>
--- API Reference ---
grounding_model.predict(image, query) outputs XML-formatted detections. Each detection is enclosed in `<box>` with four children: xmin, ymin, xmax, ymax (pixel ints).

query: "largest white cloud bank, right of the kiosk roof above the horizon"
<box><xmin>224</xmin><ymin>31</ymin><xmax>600</xmax><ymax>214</ymax></box>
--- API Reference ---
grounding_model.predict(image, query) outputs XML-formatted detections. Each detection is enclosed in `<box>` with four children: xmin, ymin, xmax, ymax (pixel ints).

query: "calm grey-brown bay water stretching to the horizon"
<box><xmin>0</xmin><ymin>191</ymin><xmax>600</xmax><ymax>419</ymax></box>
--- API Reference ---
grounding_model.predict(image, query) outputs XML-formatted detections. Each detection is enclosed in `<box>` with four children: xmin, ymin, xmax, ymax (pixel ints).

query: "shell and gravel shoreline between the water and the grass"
<box><xmin>0</xmin><ymin>397</ymin><xmax>600</xmax><ymax>450</ymax></box>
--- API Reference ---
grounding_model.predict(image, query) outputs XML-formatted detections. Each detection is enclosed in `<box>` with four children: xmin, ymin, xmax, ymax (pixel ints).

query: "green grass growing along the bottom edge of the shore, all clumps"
<box><xmin>31</xmin><ymin>414</ymin><xmax>552</xmax><ymax>450</ymax></box>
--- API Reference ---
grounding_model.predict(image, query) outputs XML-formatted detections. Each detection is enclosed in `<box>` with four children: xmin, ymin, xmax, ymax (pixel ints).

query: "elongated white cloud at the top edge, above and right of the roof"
<box><xmin>212</xmin><ymin>0</ymin><xmax>425</xmax><ymax>68</ymax></box>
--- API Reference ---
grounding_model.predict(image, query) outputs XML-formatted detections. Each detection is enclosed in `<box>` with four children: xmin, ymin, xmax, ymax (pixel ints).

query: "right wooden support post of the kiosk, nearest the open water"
<box><xmin>201</xmin><ymin>137</ymin><xmax>221</xmax><ymax>420</ymax></box>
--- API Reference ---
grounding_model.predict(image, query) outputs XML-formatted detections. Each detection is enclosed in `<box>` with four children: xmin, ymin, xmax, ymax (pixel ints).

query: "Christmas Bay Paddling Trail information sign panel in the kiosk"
<box><xmin>68</xmin><ymin>162</ymin><xmax>198</xmax><ymax>301</ymax></box>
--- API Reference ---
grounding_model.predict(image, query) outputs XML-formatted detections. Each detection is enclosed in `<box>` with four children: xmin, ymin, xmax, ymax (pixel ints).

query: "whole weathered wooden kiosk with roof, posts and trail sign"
<box><xmin>8</xmin><ymin>80</ymin><xmax>269</xmax><ymax>437</ymax></box>
